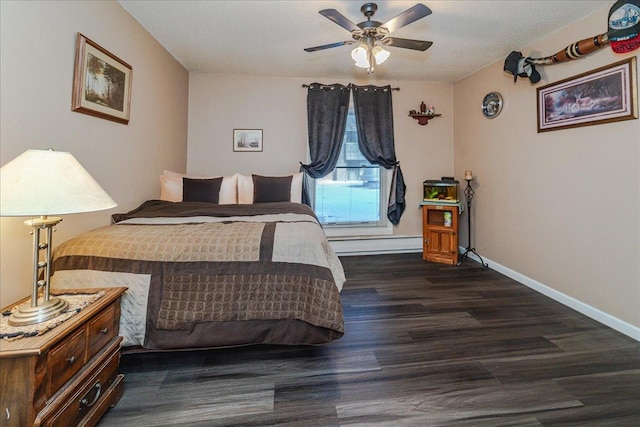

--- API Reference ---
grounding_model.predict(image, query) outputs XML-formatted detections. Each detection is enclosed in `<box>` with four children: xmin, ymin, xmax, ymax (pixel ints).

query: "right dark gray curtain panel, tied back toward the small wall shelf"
<box><xmin>351</xmin><ymin>85</ymin><xmax>407</xmax><ymax>225</ymax></box>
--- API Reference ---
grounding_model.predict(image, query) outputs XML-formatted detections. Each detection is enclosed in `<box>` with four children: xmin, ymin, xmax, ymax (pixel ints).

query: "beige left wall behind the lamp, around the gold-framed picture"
<box><xmin>0</xmin><ymin>1</ymin><xmax>189</xmax><ymax>306</ymax></box>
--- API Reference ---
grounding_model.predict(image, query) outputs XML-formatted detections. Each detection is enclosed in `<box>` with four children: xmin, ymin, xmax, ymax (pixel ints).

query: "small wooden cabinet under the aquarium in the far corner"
<box><xmin>422</xmin><ymin>202</ymin><xmax>458</xmax><ymax>265</ymax></box>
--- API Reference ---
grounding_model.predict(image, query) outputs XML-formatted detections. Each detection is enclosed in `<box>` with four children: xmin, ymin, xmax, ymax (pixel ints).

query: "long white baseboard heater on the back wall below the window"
<box><xmin>329</xmin><ymin>236</ymin><xmax>422</xmax><ymax>256</ymax></box>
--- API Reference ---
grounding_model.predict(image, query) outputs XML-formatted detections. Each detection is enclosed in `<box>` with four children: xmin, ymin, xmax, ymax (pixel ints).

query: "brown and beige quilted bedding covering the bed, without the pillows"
<box><xmin>52</xmin><ymin>176</ymin><xmax>345</xmax><ymax>350</ymax></box>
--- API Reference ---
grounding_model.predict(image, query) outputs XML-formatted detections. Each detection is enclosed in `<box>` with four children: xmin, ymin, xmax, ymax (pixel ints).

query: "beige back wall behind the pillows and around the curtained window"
<box><xmin>187</xmin><ymin>73</ymin><xmax>464</xmax><ymax>236</ymax></box>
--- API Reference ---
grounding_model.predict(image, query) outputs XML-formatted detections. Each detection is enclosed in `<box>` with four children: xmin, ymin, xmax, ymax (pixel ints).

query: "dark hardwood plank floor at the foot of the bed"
<box><xmin>100</xmin><ymin>254</ymin><xmax>640</xmax><ymax>427</ymax></box>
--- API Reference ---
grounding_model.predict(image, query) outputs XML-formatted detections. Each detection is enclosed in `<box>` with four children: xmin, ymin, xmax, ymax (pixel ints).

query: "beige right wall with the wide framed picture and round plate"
<box><xmin>454</xmin><ymin>8</ymin><xmax>640</xmax><ymax>332</ymax></box>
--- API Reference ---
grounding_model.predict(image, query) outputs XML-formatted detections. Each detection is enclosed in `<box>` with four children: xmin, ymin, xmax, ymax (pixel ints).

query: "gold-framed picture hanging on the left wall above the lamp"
<box><xmin>71</xmin><ymin>33</ymin><xmax>133</xmax><ymax>124</ymax></box>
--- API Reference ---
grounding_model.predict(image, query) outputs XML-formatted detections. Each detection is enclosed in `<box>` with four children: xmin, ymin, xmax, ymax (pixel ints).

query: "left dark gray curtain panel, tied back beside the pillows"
<box><xmin>300</xmin><ymin>83</ymin><xmax>349</xmax><ymax>204</ymax></box>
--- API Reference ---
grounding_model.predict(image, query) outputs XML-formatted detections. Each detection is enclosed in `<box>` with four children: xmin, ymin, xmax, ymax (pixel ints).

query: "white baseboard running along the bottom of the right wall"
<box><xmin>460</xmin><ymin>248</ymin><xmax>640</xmax><ymax>341</ymax></box>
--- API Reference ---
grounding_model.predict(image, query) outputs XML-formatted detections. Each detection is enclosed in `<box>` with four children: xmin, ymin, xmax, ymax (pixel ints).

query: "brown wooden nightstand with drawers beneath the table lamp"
<box><xmin>0</xmin><ymin>288</ymin><xmax>127</xmax><ymax>427</ymax></box>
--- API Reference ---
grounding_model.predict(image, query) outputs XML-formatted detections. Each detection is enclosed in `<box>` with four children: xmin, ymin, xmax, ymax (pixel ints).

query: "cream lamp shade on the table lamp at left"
<box><xmin>0</xmin><ymin>150</ymin><xmax>117</xmax><ymax>216</ymax></box>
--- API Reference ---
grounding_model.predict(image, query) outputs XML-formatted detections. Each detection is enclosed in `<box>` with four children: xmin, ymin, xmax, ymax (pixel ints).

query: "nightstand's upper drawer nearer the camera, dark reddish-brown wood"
<box><xmin>47</xmin><ymin>328</ymin><xmax>87</xmax><ymax>395</ymax></box>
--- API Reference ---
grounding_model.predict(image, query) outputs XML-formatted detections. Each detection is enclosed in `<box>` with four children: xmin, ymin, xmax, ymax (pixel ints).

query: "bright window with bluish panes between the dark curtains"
<box><xmin>312</xmin><ymin>106</ymin><xmax>388</xmax><ymax>234</ymax></box>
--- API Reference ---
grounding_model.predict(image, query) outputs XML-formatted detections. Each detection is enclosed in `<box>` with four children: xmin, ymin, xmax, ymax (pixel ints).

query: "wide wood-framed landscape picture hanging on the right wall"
<box><xmin>537</xmin><ymin>57</ymin><xmax>638</xmax><ymax>132</ymax></box>
